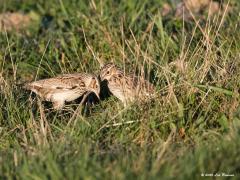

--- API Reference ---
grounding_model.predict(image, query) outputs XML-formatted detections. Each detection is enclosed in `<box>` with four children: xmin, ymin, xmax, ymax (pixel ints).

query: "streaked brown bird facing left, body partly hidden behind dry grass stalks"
<box><xmin>100</xmin><ymin>63</ymin><xmax>155</xmax><ymax>106</ymax></box>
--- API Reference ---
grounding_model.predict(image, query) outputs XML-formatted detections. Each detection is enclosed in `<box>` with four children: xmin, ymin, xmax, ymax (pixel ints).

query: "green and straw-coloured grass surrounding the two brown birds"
<box><xmin>0</xmin><ymin>0</ymin><xmax>240</xmax><ymax>179</ymax></box>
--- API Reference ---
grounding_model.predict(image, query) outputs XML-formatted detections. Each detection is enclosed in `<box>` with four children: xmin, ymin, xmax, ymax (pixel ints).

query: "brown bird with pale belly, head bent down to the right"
<box><xmin>24</xmin><ymin>73</ymin><xmax>100</xmax><ymax>110</ymax></box>
